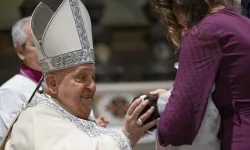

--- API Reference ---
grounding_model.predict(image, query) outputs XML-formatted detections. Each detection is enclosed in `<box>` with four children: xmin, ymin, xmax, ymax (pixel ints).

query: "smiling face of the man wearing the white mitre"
<box><xmin>45</xmin><ymin>64</ymin><xmax>96</xmax><ymax>119</ymax></box>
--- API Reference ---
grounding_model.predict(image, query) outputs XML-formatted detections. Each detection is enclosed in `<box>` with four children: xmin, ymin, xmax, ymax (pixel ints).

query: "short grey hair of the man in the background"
<box><xmin>11</xmin><ymin>17</ymin><xmax>30</xmax><ymax>48</ymax></box>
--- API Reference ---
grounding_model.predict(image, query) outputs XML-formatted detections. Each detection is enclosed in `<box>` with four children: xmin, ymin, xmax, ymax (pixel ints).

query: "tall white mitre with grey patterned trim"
<box><xmin>31</xmin><ymin>0</ymin><xmax>95</xmax><ymax>75</ymax></box>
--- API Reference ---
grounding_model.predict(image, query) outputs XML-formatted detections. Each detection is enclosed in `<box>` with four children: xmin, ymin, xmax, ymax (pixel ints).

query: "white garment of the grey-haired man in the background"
<box><xmin>0</xmin><ymin>74</ymin><xmax>37</xmax><ymax>142</ymax></box>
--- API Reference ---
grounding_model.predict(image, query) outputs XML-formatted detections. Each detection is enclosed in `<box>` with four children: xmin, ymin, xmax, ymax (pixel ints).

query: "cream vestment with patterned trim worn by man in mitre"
<box><xmin>2</xmin><ymin>93</ymin><xmax>131</xmax><ymax>150</ymax></box>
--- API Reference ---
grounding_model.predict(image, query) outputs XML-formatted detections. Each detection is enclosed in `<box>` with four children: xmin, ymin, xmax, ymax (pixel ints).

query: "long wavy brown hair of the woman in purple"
<box><xmin>151</xmin><ymin>0</ymin><xmax>233</xmax><ymax>48</ymax></box>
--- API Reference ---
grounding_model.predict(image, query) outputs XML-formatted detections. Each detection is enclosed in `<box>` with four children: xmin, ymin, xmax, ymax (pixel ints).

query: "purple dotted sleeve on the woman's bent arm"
<box><xmin>158</xmin><ymin>26</ymin><xmax>221</xmax><ymax>147</ymax></box>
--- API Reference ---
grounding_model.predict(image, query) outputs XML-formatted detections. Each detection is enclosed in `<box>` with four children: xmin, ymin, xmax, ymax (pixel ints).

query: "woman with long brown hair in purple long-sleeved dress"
<box><xmin>139</xmin><ymin>0</ymin><xmax>250</xmax><ymax>150</ymax></box>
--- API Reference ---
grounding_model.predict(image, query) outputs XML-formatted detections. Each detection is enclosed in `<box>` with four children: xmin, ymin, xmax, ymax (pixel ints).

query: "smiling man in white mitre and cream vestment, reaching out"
<box><xmin>0</xmin><ymin>0</ymin><xmax>156</xmax><ymax>150</ymax></box>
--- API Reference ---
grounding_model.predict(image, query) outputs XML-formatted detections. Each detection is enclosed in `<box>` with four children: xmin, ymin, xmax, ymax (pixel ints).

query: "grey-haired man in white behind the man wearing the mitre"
<box><xmin>0</xmin><ymin>17</ymin><xmax>42</xmax><ymax>141</ymax></box>
